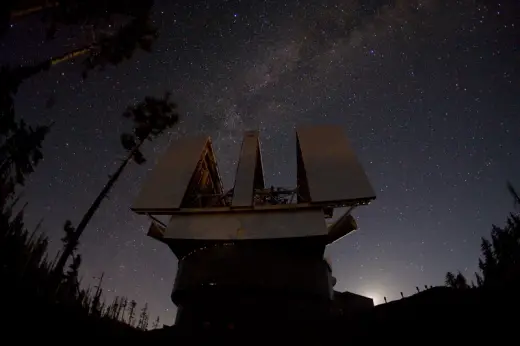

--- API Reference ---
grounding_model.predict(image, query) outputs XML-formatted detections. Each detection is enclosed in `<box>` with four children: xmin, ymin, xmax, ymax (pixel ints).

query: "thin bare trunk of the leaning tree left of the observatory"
<box><xmin>55</xmin><ymin>138</ymin><xmax>146</xmax><ymax>277</ymax></box>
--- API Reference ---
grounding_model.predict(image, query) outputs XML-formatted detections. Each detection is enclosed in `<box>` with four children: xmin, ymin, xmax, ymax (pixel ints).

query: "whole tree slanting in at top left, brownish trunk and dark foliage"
<box><xmin>0</xmin><ymin>0</ymin><xmax>158</xmax><ymax>125</ymax></box>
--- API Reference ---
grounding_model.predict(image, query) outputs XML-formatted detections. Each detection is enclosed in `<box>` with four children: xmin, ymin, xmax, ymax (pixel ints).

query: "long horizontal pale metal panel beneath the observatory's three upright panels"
<box><xmin>164</xmin><ymin>209</ymin><xmax>327</xmax><ymax>240</ymax></box>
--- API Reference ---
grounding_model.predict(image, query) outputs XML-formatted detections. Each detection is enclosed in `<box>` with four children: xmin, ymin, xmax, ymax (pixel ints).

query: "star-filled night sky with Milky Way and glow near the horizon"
<box><xmin>0</xmin><ymin>0</ymin><xmax>520</xmax><ymax>323</ymax></box>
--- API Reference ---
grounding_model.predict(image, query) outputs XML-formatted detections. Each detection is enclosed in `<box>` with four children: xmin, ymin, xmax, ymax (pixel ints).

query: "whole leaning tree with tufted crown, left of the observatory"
<box><xmin>56</xmin><ymin>94</ymin><xmax>179</xmax><ymax>273</ymax></box>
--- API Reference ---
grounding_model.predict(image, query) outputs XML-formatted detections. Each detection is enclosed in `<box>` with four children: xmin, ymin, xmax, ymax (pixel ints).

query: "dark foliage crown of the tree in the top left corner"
<box><xmin>0</xmin><ymin>0</ymin><xmax>158</xmax><ymax>82</ymax></box>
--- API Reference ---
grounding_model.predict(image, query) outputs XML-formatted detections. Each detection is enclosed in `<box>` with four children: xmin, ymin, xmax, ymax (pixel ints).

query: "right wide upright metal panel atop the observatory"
<box><xmin>297</xmin><ymin>125</ymin><xmax>375</xmax><ymax>203</ymax></box>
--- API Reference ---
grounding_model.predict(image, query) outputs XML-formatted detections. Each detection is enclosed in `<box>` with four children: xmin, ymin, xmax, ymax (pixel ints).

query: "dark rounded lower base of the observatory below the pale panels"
<box><xmin>172</xmin><ymin>239</ymin><xmax>333</xmax><ymax>327</ymax></box>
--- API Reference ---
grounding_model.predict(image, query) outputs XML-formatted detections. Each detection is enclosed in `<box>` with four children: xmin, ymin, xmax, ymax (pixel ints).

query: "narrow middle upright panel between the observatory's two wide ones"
<box><xmin>231</xmin><ymin>131</ymin><xmax>264</xmax><ymax>207</ymax></box>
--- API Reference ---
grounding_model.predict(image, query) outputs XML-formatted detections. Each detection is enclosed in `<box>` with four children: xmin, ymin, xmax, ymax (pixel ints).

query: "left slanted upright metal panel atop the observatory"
<box><xmin>132</xmin><ymin>136</ymin><xmax>209</xmax><ymax>213</ymax></box>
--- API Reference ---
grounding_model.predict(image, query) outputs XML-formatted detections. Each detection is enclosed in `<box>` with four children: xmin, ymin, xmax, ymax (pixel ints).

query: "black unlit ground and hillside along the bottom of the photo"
<box><xmin>6</xmin><ymin>287</ymin><xmax>520</xmax><ymax>345</ymax></box>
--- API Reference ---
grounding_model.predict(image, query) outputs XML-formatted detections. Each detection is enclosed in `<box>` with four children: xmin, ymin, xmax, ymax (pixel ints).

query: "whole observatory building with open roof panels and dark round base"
<box><xmin>132</xmin><ymin>126</ymin><xmax>375</xmax><ymax>327</ymax></box>
